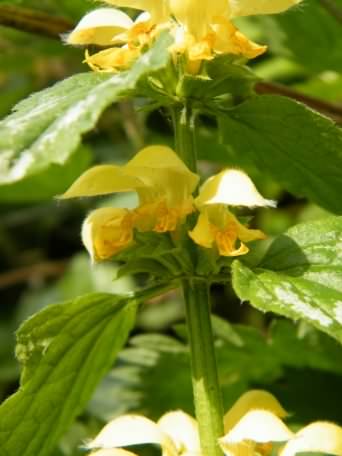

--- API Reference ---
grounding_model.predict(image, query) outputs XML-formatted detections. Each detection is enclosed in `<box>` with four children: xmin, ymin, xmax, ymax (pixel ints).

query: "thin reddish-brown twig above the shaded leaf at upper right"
<box><xmin>255</xmin><ymin>82</ymin><xmax>342</xmax><ymax>124</ymax></box>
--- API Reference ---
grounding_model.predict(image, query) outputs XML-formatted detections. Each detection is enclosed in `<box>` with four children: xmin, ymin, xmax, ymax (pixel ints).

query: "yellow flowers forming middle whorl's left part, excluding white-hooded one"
<box><xmin>61</xmin><ymin>146</ymin><xmax>199</xmax><ymax>261</ymax></box>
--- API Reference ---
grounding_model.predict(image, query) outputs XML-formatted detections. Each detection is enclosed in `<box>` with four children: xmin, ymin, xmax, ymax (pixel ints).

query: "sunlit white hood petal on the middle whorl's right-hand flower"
<box><xmin>195</xmin><ymin>169</ymin><xmax>276</xmax><ymax>207</ymax></box>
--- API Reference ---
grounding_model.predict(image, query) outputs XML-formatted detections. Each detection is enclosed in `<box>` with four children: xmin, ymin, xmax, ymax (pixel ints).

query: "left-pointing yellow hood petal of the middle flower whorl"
<box><xmin>59</xmin><ymin>165</ymin><xmax>143</xmax><ymax>199</ymax></box>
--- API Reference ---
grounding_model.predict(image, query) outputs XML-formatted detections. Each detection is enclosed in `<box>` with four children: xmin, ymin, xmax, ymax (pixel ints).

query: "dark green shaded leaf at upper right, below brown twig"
<box><xmin>219</xmin><ymin>95</ymin><xmax>342</xmax><ymax>214</ymax></box>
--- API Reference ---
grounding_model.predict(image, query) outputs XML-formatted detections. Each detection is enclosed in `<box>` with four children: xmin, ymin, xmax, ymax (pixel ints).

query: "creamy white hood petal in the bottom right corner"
<box><xmin>280</xmin><ymin>421</ymin><xmax>342</xmax><ymax>456</ymax></box>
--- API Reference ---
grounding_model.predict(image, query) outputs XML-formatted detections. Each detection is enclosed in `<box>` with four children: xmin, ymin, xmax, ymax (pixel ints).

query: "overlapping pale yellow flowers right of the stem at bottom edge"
<box><xmin>219</xmin><ymin>390</ymin><xmax>342</xmax><ymax>456</ymax></box>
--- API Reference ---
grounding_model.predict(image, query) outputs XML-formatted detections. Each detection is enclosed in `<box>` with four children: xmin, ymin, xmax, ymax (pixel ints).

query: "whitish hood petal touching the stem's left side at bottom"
<box><xmin>158</xmin><ymin>410</ymin><xmax>201</xmax><ymax>454</ymax></box>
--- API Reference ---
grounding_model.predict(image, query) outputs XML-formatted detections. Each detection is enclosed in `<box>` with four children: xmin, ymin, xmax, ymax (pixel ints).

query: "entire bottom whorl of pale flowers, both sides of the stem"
<box><xmin>84</xmin><ymin>390</ymin><xmax>342</xmax><ymax>456</ymax></box>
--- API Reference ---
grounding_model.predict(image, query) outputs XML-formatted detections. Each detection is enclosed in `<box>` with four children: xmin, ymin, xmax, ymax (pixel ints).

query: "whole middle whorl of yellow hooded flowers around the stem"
<box><xmin>61</xmin><ymin>146</ymin><xmax>275</xmax><ymax>261</ymax></box>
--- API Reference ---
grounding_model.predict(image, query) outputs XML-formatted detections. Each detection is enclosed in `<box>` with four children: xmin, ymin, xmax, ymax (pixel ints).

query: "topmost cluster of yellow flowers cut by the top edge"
<box><xmin>67</xmin><ymin>0</ymin><xmax>301</xmax><ymax>72</ymax></box>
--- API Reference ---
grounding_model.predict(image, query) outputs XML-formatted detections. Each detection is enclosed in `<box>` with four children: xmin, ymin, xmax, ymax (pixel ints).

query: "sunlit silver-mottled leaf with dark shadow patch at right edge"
<box><xmin>232</xmin><ymin>217</ymin><xmax>342</xmax><ymax>343</ymax></box>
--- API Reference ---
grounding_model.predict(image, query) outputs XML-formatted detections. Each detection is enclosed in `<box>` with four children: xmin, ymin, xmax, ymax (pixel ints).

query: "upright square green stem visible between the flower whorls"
<box><xmin>173</xmin><ymin>106</ymin><xmax>224</xmax><ymax>456</ymax></box>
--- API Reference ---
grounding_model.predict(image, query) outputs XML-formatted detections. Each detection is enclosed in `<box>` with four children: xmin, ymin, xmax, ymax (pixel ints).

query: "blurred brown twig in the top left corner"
<box><xmin>0</xmin><ymin>5</ymin><xmax>74</xmax><ymax>39</ymax></box>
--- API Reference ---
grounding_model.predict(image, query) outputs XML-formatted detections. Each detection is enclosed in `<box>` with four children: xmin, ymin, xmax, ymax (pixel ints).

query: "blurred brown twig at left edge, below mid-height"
<box><xmin>0</xmin><ymin>260</ymin><xmax>68</xmax><ymax>289</ymax></box>
